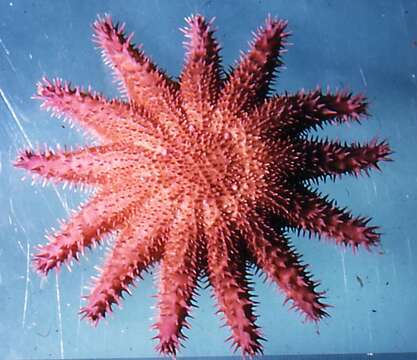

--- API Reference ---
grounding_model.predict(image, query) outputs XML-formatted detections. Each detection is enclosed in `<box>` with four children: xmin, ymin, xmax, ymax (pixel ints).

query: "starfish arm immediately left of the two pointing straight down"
<box><xmin>80</xmin><ymin>187</ymin><xmax>181</xmax><ymax>324</ymax></box>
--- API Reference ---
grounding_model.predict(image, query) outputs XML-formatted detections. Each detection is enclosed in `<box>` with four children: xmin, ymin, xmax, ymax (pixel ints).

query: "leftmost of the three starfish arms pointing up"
<box><xmin>93</xmin><ymin>16</ymin><xmax>178</xmax><ymax>115</ymax></box>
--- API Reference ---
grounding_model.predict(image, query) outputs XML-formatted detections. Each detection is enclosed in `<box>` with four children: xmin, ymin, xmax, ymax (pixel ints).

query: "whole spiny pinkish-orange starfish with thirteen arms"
<box><xmin>15</xmin><ymin>15</ymin><xmax>391</xmax><ymax>356</ymax></box>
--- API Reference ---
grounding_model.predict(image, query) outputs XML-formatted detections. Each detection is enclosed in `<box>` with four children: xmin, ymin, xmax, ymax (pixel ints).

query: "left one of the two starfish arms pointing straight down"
<box><xmin>153</xmin><ymin>202</ymin><xmax>200</xmax><ymax>355</ymax></box>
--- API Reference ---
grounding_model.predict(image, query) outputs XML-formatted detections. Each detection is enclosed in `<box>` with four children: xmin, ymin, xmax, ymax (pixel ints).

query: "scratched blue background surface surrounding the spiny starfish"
<box><xmin>0</xmin><ymin>0</ymin><xmax>417</xmax><ymax>359</ymax></box>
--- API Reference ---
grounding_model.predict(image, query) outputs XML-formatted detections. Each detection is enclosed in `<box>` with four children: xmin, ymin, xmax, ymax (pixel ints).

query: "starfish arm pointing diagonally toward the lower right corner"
<box><xmin>242</xmin><ymin>215</ymin><xmax>328</xmax><ymax>321</ymax></box>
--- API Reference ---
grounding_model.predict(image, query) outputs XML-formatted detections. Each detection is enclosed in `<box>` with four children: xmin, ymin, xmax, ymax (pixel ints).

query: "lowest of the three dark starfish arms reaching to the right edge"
<box><xmin>275</xmin><ymin>185</ymin><xmax>380</xmax><ymax>250</ymax></box>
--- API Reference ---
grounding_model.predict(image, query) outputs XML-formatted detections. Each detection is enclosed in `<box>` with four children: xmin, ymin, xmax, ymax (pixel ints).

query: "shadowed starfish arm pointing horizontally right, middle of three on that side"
<box><xmin>291</xmin><ymin>139</ymin><xmax>391</xmax><ymax>180</ymax></box>
